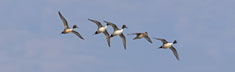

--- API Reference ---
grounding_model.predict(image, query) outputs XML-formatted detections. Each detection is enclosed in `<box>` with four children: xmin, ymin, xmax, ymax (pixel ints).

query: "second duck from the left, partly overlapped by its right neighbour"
<box><xmin>88</xmin><ymin>19</ymin><xmax>110</xmax><ymax>47</ymax></box>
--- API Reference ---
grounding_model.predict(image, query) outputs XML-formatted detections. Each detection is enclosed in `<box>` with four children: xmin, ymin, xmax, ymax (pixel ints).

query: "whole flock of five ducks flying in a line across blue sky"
<box><xmin>58</xmin><ymin>12</ymin><xmax>179</xmax><ymax>60</ymax></box>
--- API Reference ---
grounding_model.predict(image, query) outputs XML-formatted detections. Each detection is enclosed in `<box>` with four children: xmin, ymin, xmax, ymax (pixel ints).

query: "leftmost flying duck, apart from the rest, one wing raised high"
<box><xmin>58</xmin><ymin>11</ymin><xmax>84</xmax><ymax>40</ymax></box>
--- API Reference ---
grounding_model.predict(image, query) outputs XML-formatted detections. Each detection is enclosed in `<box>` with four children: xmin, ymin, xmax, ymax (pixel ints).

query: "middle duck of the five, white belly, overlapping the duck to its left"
<box><xmin>104</xmin><ymin>21</ymin><xmax>127</xmax><ymax>50</ymax></box>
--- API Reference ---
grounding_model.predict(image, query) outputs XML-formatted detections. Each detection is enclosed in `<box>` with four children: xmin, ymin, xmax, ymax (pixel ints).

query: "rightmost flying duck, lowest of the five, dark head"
<box><xmin>154</xmin><ymin>38</ymin><xmax>180</xmax><ymax>61</ymax></box>
